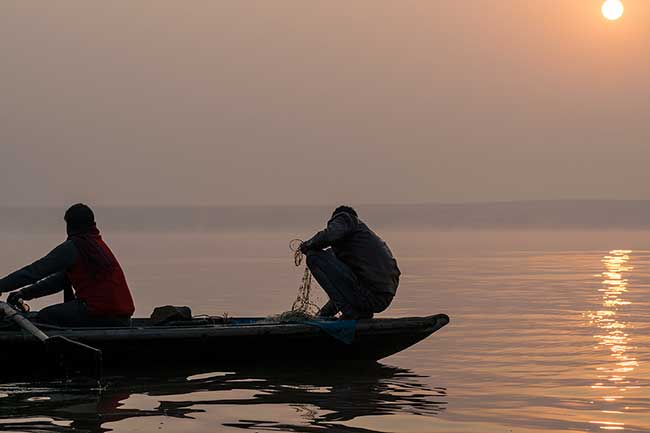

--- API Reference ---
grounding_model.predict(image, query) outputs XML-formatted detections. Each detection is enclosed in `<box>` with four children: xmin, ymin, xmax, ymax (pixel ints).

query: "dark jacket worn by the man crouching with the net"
<box><xmin>302</xmin><ymin>212</ymin><xmax>401</xmax><ymax>295</ymax></box>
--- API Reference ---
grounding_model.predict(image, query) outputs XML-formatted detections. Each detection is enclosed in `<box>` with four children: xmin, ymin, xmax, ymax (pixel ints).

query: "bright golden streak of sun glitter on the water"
<box><xmin>588</xmin><ymin>250</ymin><xmax>639</xmax><ymax>430</ymax></box>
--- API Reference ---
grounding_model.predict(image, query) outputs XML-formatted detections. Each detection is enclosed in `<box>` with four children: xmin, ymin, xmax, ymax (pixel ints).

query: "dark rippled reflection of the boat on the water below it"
<box><xmin>0</xmin><ymin>364</ymin><xmax>446</xmax><ymax>432</ymax></box>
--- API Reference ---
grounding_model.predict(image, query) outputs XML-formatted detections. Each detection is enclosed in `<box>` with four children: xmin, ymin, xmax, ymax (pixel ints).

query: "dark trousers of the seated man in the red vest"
<box><xmin>36</xmin><ymin>299</ymin><xmax>131</xmax><ymax>327</ymax></box>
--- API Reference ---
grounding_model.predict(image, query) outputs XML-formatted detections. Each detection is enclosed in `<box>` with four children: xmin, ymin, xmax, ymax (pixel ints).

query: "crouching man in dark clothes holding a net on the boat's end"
<box><xmin>300</xmin><ymin>206</ymin><xmax>400</xmax><ymax>319</ymax></box>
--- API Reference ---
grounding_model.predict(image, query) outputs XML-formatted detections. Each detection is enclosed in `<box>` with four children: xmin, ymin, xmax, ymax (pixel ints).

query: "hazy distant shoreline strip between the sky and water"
<box><xmin>0</xmin><ymin>200</ymin><xmax>650</xmax><ymax>232</ymax></box>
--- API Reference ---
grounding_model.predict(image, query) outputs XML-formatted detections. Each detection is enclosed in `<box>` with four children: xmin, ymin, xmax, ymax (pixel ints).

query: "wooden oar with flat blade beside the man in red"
<box><xmin>0</xmin><ymin>302</ymin><xmax>102</xmax><ymax>380</ymax></box>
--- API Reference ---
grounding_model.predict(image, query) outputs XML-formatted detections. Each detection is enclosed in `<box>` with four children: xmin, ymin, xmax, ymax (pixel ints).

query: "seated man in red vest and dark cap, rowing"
<box><xmin>0</xmin><ymin>203</ymin><xmax>135</xmax><ymax>327</ymax></box>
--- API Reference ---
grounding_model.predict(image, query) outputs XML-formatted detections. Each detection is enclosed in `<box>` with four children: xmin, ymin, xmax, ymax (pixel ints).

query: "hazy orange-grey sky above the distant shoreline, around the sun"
<box><xmin>0</xmin><ymin>0</ymin><xmax>650</xmax><ymax>205</ymax></box>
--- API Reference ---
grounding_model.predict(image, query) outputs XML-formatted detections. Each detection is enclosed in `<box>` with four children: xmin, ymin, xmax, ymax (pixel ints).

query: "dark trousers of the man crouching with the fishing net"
<box><xmin>307</xmin><ymin>250</ymin><xmax>393</xmax><ymax>319</ymax></box>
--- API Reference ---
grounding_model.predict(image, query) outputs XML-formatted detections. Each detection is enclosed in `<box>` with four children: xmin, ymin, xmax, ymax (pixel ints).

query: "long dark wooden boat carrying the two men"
<box><xmin>0</xmin><ymin>314</ymin><xmax>449</xmax><ymax>372</ymax></box>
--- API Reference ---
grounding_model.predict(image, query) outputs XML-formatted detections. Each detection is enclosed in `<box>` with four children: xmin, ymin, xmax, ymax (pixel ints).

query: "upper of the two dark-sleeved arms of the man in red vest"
<box><xmin>0</xmin><ymin>241</ymin><xmax>78</xmax><ymax>293</ymax></box>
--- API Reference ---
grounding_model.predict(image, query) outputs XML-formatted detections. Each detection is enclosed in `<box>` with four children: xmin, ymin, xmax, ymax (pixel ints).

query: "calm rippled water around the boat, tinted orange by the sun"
<box><xmin>0</xmin><ymin>231</ymin><xmax>650</xmax><ymax>433</ymax></box>
